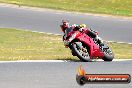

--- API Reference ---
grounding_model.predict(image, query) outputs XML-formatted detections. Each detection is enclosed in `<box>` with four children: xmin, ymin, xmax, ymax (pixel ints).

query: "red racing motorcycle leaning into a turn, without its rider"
<box><xmin>63</xmin><ymin>29</ymin><xmax>114</xmax><ymax>62</ymax></box>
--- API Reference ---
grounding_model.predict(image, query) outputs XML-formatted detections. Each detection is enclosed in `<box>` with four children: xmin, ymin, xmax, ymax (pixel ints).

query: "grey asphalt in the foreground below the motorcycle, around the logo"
<box><xmin>0</xmin><ymin>61</ymin><xmax>132</xmax><ymax>88</ymax></box>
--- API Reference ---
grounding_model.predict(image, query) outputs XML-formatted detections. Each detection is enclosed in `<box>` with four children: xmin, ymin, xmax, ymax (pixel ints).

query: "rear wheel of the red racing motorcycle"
<box><xmin>102</xmin><ymin>44</ymin><xmax>114</xmax><ymax>61</ymax></box>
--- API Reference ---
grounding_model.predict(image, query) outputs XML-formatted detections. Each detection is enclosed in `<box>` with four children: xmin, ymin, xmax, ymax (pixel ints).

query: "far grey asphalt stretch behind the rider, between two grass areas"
<box><xmin>0</xmin><ymin>5</ymin><xmax>132</xmax><ymax>43</ymax></box>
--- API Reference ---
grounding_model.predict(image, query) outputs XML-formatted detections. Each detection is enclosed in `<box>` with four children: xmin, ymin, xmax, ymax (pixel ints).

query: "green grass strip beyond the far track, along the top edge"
<box><xmin>0</xmin><ymin>0</ymin><xmax>132</xmax><ymax>16</ymax></box>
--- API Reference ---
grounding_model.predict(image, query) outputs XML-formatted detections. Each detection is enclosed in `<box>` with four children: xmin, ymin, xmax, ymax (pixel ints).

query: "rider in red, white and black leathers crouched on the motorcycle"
<box><xmin>60</xmin><ymin>20</ymin><xmax>103</xmax><ymax>45</ymax></box>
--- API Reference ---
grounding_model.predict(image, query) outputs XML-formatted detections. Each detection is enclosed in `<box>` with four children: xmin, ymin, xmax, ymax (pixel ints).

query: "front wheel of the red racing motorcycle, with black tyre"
<box><xmin>71</xmin><ymin>42</ymin><xmax>91</xmax><ymax>62</ymax></box>
